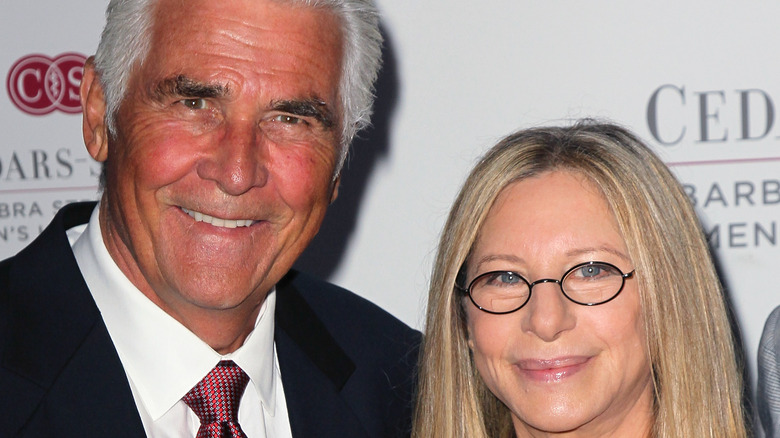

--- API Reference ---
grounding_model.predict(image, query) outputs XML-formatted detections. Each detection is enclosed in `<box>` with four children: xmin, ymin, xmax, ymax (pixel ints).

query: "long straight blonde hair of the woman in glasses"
<box><xmin>413</xmin><ymin>120</ymin><xmax>747</xmax><ymax>438</ymax></box>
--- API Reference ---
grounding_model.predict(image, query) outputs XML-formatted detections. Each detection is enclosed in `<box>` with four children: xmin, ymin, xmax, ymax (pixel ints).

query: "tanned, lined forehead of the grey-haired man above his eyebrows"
<box><xmin>142</xmin><ymin>0</ymin><xmax>344</xmax><ymax>73</ymax></box>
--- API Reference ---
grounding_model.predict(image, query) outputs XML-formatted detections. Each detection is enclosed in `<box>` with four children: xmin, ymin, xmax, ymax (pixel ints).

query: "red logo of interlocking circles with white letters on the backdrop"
<box><xmin>6</xmin><ymin>53</ymin><xmax>87</xmax><ymax>116</ymax></box>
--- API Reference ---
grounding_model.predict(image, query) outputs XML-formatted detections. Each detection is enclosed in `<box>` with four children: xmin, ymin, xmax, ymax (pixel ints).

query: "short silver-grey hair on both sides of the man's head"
<box><xmin>95</xmin><ymin>0</ymin><xmax>382</xmax><ymax>173</ymax></box>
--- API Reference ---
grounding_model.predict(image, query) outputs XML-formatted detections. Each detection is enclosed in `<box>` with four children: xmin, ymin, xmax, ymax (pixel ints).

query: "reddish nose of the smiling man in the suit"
<box><xmin>198</xmin><ymin>121</ymin><xmax>269</xmax><ymax>196</ymax></box>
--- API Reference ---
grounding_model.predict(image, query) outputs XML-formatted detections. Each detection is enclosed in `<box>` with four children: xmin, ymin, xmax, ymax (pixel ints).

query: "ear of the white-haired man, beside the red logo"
<box><xmin>79</xmin><ymin>56</ymin><xmax>108</xmax><ymax>162</ymax></box>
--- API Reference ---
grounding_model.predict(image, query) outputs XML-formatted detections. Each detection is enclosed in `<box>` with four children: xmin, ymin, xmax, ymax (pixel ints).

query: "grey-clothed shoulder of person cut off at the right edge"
<box><xmin>757</xmin><ymin>307</ymin><xmax>780</xmax><ymax>438</ymax></box>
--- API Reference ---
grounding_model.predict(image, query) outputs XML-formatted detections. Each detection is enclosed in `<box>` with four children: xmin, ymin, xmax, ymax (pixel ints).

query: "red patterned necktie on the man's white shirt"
<box><xmin>182</xmin><ymin>360</ymin><xmax>249</xmax><ymax>438</ymax></box>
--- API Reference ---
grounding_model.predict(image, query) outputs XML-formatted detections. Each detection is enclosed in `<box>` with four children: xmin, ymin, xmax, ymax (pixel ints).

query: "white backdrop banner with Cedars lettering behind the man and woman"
<box><xmin>0</xmin><ymin>0</ymin><xmax>780</xmax><ymax>420</ymax></box>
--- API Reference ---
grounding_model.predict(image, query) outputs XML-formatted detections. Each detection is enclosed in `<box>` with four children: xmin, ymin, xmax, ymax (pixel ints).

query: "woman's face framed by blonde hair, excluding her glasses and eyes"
<box><xmin>463</xmin><ymin>171</ymin><xmax>653</xmax><ymax>437</ymax></box>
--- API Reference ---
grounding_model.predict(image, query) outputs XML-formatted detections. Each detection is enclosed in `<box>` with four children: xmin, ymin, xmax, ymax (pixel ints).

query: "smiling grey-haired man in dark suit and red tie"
<box><xmin>0</xmin><ymin>0</ymin><xmax>419</xmax><ymax>438</ymax></box>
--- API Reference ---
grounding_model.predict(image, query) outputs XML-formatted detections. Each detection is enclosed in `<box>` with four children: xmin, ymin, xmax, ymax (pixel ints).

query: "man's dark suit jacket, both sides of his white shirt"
<box><xmin>0</xmin><ymin>203</ymin><xmax>419</xmax><ymax>438</ymax></box>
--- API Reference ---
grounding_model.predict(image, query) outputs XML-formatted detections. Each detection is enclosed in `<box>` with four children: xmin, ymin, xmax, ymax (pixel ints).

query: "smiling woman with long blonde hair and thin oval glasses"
<box><xmin>414</xmin><ymin>121</ymin><xmax>747</xmax><ymax>438</ymax></box>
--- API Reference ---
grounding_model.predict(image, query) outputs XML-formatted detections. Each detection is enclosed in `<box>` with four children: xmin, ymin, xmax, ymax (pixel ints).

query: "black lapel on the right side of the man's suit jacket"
<box><xmin>274</xmin><ymin>274</ymin><xmax>368</xmax><ymax>438</ymax></box>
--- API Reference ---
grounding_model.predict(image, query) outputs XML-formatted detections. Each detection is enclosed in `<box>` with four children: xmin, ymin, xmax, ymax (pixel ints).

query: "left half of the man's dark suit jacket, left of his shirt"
<box><xmin>2</xmin><ymin>204</ymin><xmax>144</xmax><ymax>437</ymax></box>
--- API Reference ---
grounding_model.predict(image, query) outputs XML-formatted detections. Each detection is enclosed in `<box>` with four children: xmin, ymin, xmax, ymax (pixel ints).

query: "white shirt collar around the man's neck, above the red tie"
<box><xmin>69</xmin><ymin>205</ymin><xmax>279</xmax><ymax>420</ymax></box>
